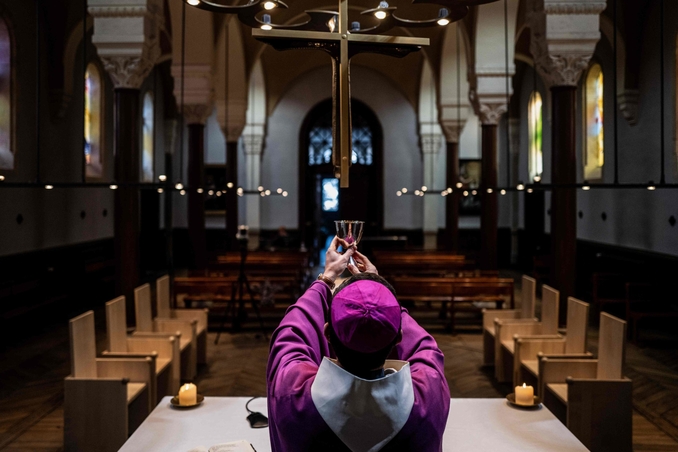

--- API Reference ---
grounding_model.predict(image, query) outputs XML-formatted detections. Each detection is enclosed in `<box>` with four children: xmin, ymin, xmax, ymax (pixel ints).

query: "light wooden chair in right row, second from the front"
<box><xmin>513</xmin><ymin>297</ymin><xmax>593</xmax><ymax>395</ymax></box>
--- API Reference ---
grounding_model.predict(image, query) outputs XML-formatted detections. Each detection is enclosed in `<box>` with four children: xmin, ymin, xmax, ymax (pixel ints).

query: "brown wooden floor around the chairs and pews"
<box><xmin>0</xmin><ymin>298</ymin><xmax>678</xmax><ymax>452</ymax></box>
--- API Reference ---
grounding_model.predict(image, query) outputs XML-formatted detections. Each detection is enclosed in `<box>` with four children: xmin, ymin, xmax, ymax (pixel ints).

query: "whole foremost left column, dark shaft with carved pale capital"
<box><xmin>88</xmin><ymin>0</ymin><xmax>162</xmax><ymax>314</ymax></box>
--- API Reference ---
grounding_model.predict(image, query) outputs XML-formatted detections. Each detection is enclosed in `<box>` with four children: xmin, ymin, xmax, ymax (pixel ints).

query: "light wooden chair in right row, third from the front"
<box><xmin>494</xmin><ymin>285</ymin><xmax>562</xmax><ymax>383</ymax></box>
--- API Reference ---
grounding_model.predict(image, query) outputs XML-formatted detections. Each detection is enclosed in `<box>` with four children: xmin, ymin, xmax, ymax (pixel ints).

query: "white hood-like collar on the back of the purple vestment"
<box><xmin>311</xmin><ymin>357</ymin><xmax>414</xmax><ymax>452</ymax></box>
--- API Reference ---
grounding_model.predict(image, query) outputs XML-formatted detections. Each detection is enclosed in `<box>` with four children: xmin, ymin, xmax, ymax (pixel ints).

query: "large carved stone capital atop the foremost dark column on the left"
<box><xmin>88</xmin><ymin>0</ymin><xmax>163</xmax><ymax>89</ymax></box>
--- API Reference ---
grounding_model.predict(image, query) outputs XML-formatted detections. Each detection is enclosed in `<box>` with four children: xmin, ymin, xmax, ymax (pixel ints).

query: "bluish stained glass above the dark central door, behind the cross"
<box><xmin>308</xmin><ymin>115</ymin><xmax>373</xmax><ymax>165</ymax></box>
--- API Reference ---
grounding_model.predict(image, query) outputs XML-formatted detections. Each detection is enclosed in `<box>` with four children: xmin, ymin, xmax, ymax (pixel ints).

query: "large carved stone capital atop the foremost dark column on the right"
<box><xmin>527</xmin><ymin>0</ymin><xmax>607</xmax><ymax>87</ymax></box>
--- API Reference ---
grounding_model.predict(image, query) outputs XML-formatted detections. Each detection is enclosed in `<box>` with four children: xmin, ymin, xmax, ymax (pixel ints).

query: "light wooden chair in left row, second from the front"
<box><xmin>103</xmin><ymin>297</ymin><xmax>181</xmax><ymax>406</ymax></box>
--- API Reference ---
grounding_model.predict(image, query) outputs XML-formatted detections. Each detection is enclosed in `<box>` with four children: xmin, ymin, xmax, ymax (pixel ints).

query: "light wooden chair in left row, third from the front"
<box><xmin>134</xmin><ymin>284</ymin><xmax>198</xmax><ymax>380</ymax></box>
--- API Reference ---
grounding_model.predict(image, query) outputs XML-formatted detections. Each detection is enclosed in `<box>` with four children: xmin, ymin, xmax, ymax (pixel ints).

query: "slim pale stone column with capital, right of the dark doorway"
<box><xmin>421</xmin><ymin>133</ymin><xmax>443</xmax><ymax>250</ymax></box>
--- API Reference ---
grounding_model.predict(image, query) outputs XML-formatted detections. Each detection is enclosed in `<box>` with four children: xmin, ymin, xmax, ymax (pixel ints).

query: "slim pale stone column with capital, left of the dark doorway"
<box><xmin>242</xmin><ymin>131</ymin><xmax>264</xmax><ymax>250</ymax></box>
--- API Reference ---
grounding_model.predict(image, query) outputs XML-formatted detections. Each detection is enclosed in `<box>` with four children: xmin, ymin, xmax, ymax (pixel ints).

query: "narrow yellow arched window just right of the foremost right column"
<box><xmin>584</xmin><ymin>64</ymin><xmax>605</xmax><ymax>181</ymax></box>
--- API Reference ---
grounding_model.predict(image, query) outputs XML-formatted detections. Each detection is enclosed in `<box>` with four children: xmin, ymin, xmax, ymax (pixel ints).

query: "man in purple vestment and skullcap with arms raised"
<box><xmin>266</xmin><ymin>237</ymin><xmax>450</xmax><ymax>452</ymax></box>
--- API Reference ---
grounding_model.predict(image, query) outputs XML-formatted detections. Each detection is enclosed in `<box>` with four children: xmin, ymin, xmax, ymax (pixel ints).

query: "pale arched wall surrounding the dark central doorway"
<box><xmin>261</xmin><ymin>65</ymin><xmax>423</xmax><ymax>229</ymax></box>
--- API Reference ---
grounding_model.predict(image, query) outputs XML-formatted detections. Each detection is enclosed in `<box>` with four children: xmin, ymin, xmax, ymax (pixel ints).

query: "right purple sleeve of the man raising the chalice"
<box><xmin>396</xmin><ymin>309</ymin><xmax>450</xmax><ymax>451</ymax></box>
